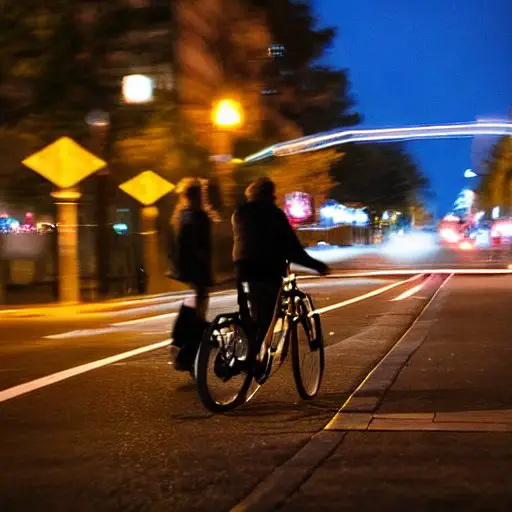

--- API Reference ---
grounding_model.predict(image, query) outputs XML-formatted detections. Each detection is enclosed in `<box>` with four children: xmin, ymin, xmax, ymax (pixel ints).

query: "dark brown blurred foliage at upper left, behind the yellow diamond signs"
<box><xmin>0</xmin><ymin>0</ymin><xmax>208</xmax><ymax>206</ymax></box>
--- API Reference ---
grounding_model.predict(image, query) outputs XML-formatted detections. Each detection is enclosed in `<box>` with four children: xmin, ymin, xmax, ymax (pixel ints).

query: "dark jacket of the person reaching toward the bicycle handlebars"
<box><xmin>231</xmin><ymin>201</ymin><xmax>327</xmax><ymax>282</ymax></box>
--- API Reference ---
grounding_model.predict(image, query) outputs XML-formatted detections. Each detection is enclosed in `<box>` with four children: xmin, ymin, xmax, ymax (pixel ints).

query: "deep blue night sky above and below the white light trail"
<box><xmin>313</xmin><ymin>0</ymin><xmax>512</xmax><ymax>215</ymax></box>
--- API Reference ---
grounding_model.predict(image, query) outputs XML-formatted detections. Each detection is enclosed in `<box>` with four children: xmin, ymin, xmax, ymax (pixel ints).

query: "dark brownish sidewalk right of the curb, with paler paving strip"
<box><xmin>282</xmin><ymin>277</ymin><xmax>512</xmax><ymax>511</ymax></box>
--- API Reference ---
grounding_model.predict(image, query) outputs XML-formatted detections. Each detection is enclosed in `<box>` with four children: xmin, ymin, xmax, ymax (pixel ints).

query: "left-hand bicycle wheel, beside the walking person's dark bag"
<box><xmin>195</xmin><ymin>315</ymin><xmax>252</xmax><ymax>413</ymax></box>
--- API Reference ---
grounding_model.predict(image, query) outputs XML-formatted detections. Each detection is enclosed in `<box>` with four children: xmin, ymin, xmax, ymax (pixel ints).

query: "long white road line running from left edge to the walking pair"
<box><xmin>0</xmin><ymin>339</ymin><xmax>171</xmax><ymax>402</ymax></box>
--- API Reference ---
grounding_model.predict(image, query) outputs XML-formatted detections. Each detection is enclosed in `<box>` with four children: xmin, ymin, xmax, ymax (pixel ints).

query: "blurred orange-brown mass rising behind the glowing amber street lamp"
<box><xmin>174</xmin><ymin>0</ymin><xmax>269</xmax><ymax>150</ymax></box>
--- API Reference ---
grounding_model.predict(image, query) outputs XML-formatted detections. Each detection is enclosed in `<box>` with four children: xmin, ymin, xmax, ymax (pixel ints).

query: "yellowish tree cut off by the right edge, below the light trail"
<box><xmin>479</xmin><ymin>137</ymin><xmax>512</xmax><ymax>213</ymax></box>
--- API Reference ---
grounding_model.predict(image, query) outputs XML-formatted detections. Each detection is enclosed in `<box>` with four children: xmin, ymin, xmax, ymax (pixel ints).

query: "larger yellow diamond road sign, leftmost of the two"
<box><xmin>23</xmin><ymin>137</ymin><xmax>106</xmax><ymax>188</ymax></box>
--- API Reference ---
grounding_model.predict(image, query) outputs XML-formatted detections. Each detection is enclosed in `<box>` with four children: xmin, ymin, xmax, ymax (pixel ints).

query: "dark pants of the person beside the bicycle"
<box><xmin>238</xmin><ymin>281</ymin><xmax>281</xmax><ymax>352</ymax></box>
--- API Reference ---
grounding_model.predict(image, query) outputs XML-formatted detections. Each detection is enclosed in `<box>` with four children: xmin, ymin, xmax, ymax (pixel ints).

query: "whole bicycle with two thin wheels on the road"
<box><xmin>194</xmin><ymin>274</ymin><xmax>325</xmax><ymax>412</ymax></box>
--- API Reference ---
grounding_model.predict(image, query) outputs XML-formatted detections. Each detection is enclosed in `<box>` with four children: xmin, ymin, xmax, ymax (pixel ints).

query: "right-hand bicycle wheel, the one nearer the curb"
<box><xmin>292</xmin><ymin>295</ymin><xmax>325</xmax><ymax>400</ymax></box>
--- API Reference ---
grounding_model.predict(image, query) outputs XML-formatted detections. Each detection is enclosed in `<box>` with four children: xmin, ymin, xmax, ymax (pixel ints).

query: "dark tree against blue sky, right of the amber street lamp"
<box><xmin>247</xmin><ymin>0</ymin><xmax>360</xmax><ymax>139</ymax></box>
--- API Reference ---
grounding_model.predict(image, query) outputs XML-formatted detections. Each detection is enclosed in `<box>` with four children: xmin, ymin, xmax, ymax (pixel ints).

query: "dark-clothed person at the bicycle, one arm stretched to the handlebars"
<box><xmin>232</xmin><ymin>178</ymin><xmax>329</xmax><ymax>353</ymax></box>
